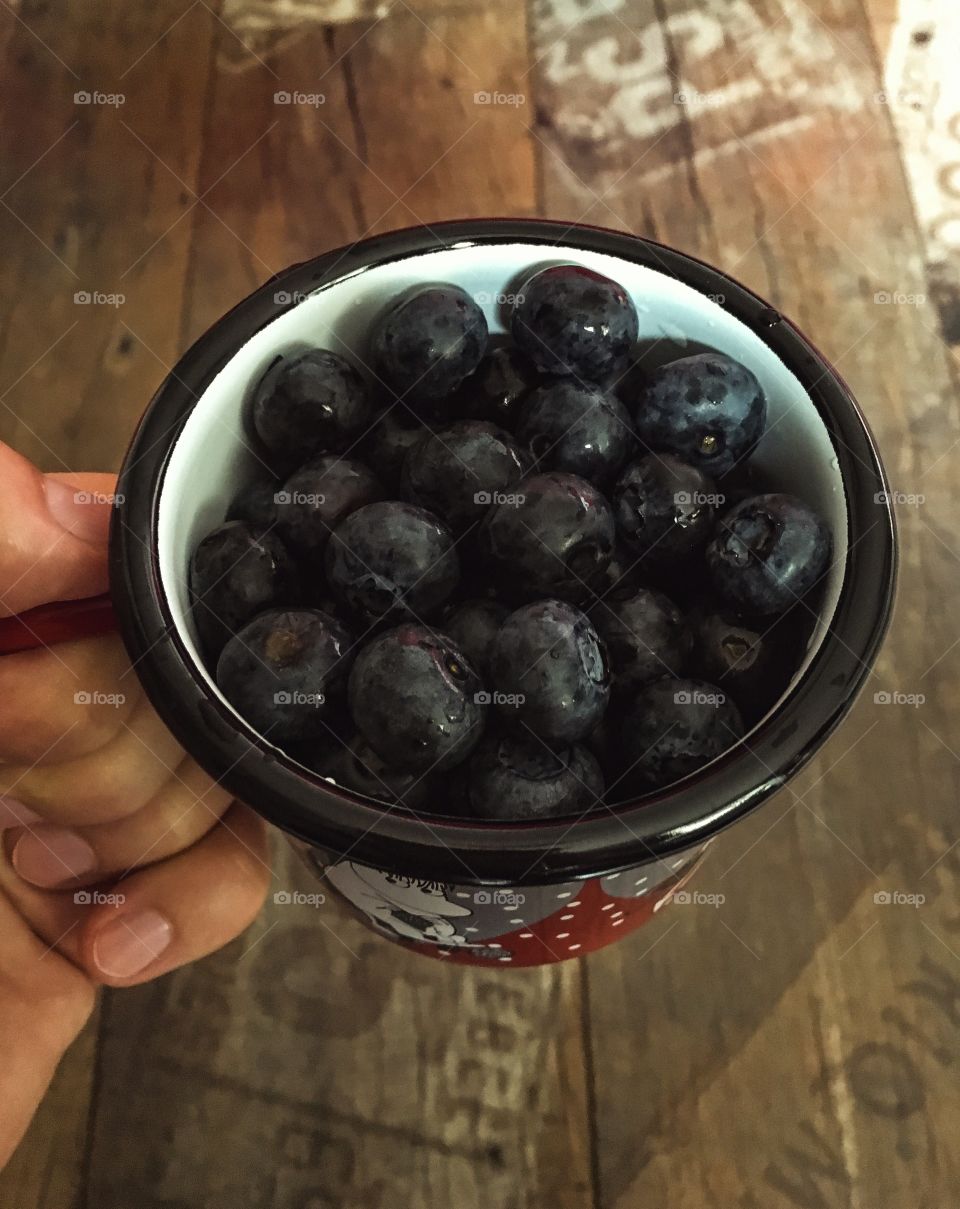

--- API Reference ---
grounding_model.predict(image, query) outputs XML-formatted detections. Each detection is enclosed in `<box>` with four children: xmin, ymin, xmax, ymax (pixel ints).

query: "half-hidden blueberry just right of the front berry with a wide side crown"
<box><xmin>590</xmin><ymin>589</ymin><xmax>690</xmax><ymax>698</ymax></box>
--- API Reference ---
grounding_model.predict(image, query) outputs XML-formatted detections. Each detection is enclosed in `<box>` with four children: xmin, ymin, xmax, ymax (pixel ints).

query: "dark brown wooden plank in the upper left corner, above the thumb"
<box><xmin>0</xmin><ymin>0</ymin><xmax>212</xmax><ymax>470</ymax></box>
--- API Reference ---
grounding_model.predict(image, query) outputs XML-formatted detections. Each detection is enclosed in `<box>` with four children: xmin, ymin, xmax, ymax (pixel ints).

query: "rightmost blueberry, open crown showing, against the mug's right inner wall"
<box><xmin>706</xmin><ymin>493</ymin><xmax>832</xmax><ymax>617</ymax></box>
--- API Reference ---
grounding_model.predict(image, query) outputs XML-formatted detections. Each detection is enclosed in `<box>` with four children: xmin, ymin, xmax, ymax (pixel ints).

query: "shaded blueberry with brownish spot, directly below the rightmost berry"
<box><xmin>688</xmin><ymin>609</ymin><xmax>783</xmax><ymax>722</ymax></box>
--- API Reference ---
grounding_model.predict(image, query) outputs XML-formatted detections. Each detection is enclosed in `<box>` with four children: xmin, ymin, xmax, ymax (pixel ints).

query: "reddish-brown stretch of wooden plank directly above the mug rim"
<box><xmin>184</xmin><ymin>2</ymin><xmax>534</xmax><ymax>343</ymax></box>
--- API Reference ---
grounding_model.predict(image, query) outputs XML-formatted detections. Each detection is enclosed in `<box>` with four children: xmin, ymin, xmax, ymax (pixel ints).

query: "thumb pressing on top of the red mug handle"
<box><xmin>0</xmin><ymin>441</ymin><xmax>116</xmax><ymax>617</ymax></box>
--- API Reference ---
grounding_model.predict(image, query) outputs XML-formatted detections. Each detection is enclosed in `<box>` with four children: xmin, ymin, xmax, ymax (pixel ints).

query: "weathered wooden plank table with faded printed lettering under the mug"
<box><xmin>0</xmin><ymin>0</ymin><xmax>960</xmax><ymax>1209</ymax></box>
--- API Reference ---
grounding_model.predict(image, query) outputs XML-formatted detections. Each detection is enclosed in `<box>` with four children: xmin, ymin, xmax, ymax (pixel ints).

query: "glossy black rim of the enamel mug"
<box><xmin>110</xmin><ymin>219</ymin><xmax>897</xmax><ymax>885</ymax></box>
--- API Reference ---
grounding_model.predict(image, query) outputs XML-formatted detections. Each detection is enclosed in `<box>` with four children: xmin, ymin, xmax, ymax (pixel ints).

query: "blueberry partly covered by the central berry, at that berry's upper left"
<box><xmin>400</xmin><ymin>420</ymin><xmax>530</xmax><ymax>532</ymax></box>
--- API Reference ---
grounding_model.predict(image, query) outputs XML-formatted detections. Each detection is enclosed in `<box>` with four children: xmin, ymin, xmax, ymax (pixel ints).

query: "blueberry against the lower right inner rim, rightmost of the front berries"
<box><xmin>607</xmin><ymin>677</ymin><xmax>744</xmax><ymax>800</ymax></box>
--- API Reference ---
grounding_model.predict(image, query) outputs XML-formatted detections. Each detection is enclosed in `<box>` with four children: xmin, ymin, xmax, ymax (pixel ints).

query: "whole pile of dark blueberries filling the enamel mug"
<box><xmin>190</xmin><ymin>265</ymin><xmax>831</xmax><ymax>821</ymax></box>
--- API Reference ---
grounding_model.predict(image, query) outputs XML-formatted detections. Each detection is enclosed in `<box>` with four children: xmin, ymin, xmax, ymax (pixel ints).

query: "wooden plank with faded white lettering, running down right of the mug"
<box><xmin>534</xmin><ymin>0</ymin><xmax>960</xmax><ymax>1209</ymax></box>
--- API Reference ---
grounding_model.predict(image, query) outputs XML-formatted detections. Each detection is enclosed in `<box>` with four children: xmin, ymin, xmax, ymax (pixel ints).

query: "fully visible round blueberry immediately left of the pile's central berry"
<box><xmin>325</xmin><ymin>499</ymin><xmax>459</xmax><ymax>620</ymax></box>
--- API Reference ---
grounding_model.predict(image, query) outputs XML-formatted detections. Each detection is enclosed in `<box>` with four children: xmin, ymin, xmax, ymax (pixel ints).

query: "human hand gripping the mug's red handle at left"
<box><xmin>0</xmin><ymin>444</ymin><xmax>270</xmax><ymax>1165</ymax></box>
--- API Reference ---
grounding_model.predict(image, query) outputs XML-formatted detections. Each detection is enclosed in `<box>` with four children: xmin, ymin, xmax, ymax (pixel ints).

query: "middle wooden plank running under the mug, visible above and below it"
<box><xmin>82</xmin><ymin>4</ymin><xmax>590</xmax><ymax>1209</ymax></box>
